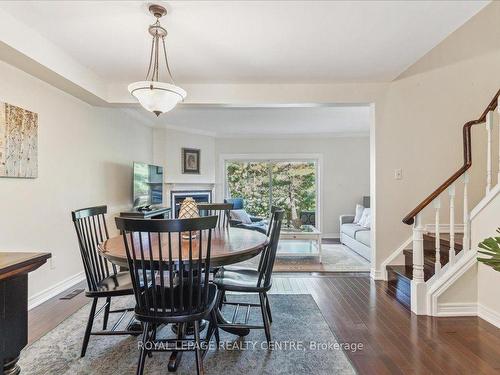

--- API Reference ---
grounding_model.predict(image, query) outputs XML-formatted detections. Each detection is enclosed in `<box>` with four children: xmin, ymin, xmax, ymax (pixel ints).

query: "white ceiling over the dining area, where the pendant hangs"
<box><xmin>0</xmin><ymin>1</ymin><xmax>488</xmax><ymax>85</ymax></box>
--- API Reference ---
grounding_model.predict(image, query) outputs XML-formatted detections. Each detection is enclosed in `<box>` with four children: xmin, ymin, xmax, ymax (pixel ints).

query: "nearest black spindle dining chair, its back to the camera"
<box><xmin>115</xmin><ymin>216</ymin><xmax>218</xmax><ymax>374</ymax></box>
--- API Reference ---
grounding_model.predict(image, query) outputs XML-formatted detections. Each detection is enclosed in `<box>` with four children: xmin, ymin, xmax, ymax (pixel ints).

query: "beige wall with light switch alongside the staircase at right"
<box><xmin>376</xmin><ymin>2</ymin><xmax>500</xmax><ymax>320</ymax></box>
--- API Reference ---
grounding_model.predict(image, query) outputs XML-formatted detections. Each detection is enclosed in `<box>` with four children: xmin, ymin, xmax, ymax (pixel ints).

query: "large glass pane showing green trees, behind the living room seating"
<box><xmin>226</xmin><ymin>160</ymin><xmax>318</xmax><ymax>225</ymax></box>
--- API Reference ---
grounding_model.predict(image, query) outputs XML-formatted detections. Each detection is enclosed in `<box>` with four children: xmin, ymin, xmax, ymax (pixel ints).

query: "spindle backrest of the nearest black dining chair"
<box><xmin>116</xmin><ymin>216</ymin><xmax>218</xmax><ymax>321</ymax></box>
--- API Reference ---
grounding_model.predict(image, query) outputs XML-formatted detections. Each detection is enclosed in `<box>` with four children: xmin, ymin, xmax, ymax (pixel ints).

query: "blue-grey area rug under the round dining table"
<box><xmin>19</xmin><ymin>294</ymin><xmax>355</xmax><ymax>375</ymax></box>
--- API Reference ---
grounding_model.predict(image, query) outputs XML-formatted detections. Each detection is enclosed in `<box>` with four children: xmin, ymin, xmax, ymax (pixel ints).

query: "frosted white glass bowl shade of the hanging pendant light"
<box><xmin>128</xmin><ymin>81</ymin><xmax>186</xmax><ymax>116</ymax></box>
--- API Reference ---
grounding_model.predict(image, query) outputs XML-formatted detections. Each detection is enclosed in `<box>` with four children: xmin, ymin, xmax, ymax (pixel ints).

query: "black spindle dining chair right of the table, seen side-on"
<box><xmin>214</xmin><ymin>208</ymin><xmax>284</xmax><ymax>342</ymax></box>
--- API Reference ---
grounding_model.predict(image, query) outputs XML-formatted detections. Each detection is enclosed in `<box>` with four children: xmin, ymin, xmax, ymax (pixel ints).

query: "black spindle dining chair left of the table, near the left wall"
<box><xmin>71</xmin><ymin>206</ymin><xmax>138</xmax><ymax>357</ymax></box>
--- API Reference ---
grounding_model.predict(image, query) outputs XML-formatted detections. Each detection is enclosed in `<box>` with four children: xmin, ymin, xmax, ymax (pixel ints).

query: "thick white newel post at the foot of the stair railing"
<box><xmin>411</xmin><ymin>213</ymin><xmax>427</xmax><ymax>315</ymax></box>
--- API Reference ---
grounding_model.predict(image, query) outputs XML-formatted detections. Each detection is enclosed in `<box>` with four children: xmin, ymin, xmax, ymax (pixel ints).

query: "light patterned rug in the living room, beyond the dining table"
<box><xmin>232</xmin><ymin>241</ymin><xmax>370</xmax><ymax>272</ymax></box>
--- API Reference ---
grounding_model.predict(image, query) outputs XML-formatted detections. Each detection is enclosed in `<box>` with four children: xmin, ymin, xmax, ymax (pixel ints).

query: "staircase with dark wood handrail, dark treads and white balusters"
<box><xmin>386</xmin><ymin>90</ymin><xmax>500</xmax><ymax>315</ymax></box>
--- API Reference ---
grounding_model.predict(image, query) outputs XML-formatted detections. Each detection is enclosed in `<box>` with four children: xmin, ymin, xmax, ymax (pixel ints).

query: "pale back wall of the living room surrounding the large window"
<box><xmin>215</xmin><ymin>137</ymin><xmax>370</xmax><ymax>236</ymax></box>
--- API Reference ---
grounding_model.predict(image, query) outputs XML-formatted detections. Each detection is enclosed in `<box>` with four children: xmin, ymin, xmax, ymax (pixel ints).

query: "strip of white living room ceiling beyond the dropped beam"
<box><xmin>143</xmin><ymin>105</ymin><xmax>370</xmax><ymax>137</ymax></box>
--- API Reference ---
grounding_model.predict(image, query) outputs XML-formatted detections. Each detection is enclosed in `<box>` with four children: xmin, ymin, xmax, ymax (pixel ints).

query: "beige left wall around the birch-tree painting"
<box><xmin>0</xmin><ymin>62</ymin><xmax>152</xmax><ymax>296</ymax></box>
